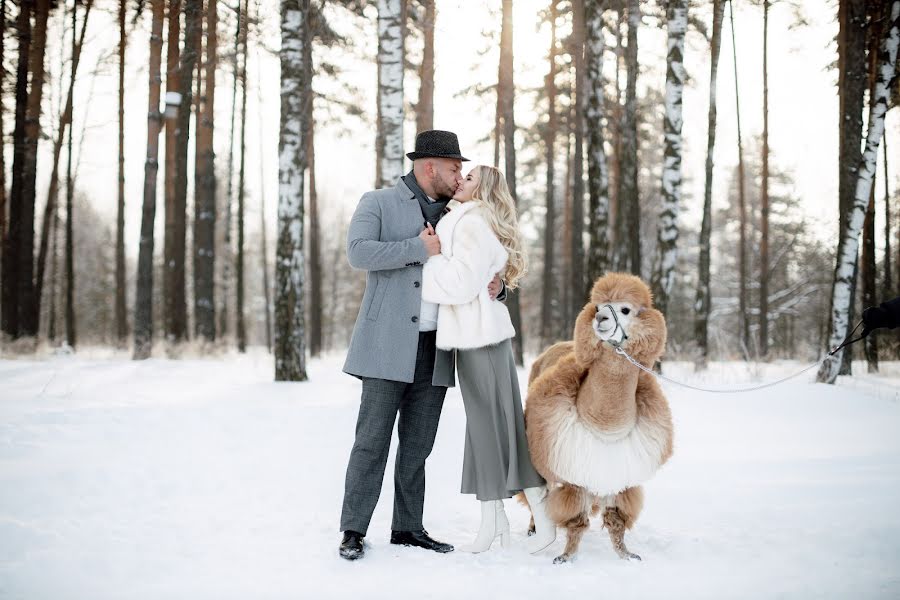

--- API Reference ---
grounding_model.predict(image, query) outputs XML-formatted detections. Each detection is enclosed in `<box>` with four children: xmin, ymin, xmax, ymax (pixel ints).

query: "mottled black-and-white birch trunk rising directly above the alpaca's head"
<box><xmin>583</xmin><ymin>1</ymin><xmax>610</xmax><ymax>298</ymax></box>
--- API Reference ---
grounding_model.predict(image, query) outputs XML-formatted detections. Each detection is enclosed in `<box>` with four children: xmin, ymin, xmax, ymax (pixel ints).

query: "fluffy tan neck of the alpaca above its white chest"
<box><xmin>575</xmin><ymin>352</ymin><xmax>639</xmax><ymax>439</ymax></box>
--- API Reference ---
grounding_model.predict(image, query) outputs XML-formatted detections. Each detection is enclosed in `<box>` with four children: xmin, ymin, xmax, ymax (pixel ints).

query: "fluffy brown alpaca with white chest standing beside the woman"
<box><xmin>525</xmin><ymin>273</ymin><xmax>673</xmax><ymax>562</ymax></box>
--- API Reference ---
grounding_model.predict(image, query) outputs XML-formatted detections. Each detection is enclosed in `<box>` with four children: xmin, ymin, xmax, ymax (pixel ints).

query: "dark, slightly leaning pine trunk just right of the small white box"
<box><xmin>166</xmin><ymin>0</ymin><xmax>202</xmax><ymax>343</ymax></box>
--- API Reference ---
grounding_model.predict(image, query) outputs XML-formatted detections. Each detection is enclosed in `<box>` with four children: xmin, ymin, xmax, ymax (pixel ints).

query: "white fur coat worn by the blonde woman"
<box><xmin>422</xmin><ymin>200</ymin><xmax>516</xmax><ymax>350</ymax></box>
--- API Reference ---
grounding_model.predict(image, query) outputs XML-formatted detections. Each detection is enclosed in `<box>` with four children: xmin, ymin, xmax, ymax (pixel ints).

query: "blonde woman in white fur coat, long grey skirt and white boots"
<box><xmin>422</xmin><ymin>165</ymin><xmax>556</xmax><ymax>552</ymax></box>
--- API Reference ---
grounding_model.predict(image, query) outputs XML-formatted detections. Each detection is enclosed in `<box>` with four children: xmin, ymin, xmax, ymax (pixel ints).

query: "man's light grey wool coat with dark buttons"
<box><xmin>344</xmin><ymin>179</ymin><xmax>455</xmax><ymax>387</ymax></box>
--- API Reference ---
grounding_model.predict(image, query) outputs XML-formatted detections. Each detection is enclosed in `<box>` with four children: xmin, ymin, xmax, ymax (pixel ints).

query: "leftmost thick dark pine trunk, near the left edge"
<box><xmin>0</xmin><ymin>0</ymin><xmax>26</xmax><ymax>338</ymax></box>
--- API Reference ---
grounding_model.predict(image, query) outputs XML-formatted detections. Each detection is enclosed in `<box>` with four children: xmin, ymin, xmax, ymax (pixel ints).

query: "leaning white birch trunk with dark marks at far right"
<box><xmin>817</xmin><ymin>0</ymin><xmax>900</xmax><ymax>383</ymax></box>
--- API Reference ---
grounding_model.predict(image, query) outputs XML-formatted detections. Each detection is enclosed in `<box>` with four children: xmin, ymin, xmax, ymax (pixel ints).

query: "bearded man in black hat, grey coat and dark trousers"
<box><xmin>339</xmin><ymin>131</ymin><xmax>496</xmax><ymax>560</ymax></box>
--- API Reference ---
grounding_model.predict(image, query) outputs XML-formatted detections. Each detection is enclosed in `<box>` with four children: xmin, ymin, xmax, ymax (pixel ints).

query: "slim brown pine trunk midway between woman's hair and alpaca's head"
<box><xmin>541</xmin><ymin>0</ymin><xmax>558</xmax><ymax>347</ymax></box>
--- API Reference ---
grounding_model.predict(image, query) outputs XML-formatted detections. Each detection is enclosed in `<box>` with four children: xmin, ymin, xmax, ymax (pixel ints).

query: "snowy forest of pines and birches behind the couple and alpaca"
<box><xmin>0</xmin><ymin>0</ymin><xmax>900</xmax><ymax>379</ymax></box>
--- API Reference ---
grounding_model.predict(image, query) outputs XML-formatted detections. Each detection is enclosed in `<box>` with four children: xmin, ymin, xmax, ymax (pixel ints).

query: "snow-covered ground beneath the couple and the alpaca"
<box><xmin>0</xmin><ymin>352</ymin><xmax>900</xmax><ymax>600</ymax></box>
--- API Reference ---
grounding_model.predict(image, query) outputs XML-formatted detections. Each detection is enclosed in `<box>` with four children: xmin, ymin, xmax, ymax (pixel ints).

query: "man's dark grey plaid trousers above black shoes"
<box><xmin>341</xmin><ymin>331</ymin><xmax>447</xmax><ymax>535</ymax></box>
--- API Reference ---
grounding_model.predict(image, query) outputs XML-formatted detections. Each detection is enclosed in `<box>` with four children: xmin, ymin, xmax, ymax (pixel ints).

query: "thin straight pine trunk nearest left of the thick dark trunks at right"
<box><xmin>759</xmin><ymin>0</ymin><xmax>770</xmax><ymax>360</ymax></box>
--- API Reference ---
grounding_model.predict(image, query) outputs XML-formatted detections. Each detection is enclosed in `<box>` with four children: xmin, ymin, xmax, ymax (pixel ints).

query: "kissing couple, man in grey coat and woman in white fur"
<box><xmin>339</xmin><ymin>130</ymin><xmax>556</xmax><ymax>560</ymax></box>
